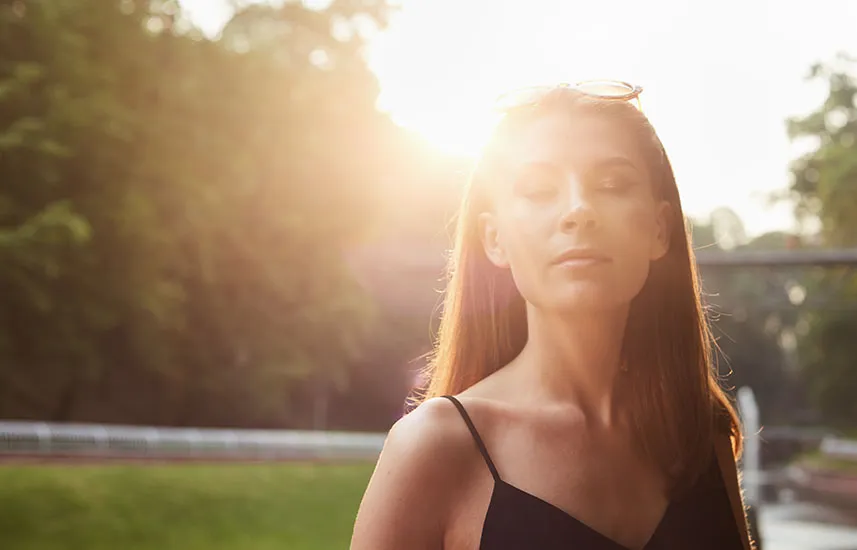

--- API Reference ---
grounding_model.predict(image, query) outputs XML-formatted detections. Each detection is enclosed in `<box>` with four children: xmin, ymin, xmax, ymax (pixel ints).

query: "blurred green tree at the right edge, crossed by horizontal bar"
<box><xmin>788</xmin><ymin>54</ymin><xmax>857</xmax><ymax>426</ymax></box>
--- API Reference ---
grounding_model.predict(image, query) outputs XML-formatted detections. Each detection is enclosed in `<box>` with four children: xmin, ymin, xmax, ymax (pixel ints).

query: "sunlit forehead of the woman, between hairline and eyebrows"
<box><xmin>500</xmin><ymin>113</ymin><xmax>648</xmax><ymax>175</ymax></box>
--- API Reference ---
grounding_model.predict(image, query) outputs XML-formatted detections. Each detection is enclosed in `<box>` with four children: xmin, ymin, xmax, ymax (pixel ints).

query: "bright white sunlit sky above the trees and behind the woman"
<box><xmin>176</xmin><ymin>0</ymin><xmax>857</xmax><ymax>235</ymax></box>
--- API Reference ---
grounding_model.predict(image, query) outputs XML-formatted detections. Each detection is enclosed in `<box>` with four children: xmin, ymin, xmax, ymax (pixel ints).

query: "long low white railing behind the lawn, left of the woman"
<box><xmin>0</xmin><ymin>421</ymin><xmax>386</xmax><ymax>460</ymax></box>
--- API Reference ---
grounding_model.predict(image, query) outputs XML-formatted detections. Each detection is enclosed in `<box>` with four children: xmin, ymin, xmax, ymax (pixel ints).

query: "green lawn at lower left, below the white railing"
<box><xmin>0</xmin><ymin>464</ymin><xmax>372</xmax><ymax>550</ymax></box>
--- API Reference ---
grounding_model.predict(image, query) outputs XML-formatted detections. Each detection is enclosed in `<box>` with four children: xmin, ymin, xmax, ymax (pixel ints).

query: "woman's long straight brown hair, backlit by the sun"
<box><xmin>422</xmin><ymin>88</ymin><xmax>741</xmax><ymax>492</ymax></box>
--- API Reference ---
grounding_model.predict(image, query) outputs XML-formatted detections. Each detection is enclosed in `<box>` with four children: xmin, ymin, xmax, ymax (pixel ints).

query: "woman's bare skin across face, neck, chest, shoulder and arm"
<box><xmin>351</xmin><ymin>112</ymin><xmax>749</xmax><ymax>550</ymax></box>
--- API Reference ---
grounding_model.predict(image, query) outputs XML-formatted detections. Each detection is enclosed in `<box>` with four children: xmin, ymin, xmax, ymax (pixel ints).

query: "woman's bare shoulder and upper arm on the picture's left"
<box><xmin>351</xmin><ymin>398</ymin><xmax>479</xmax><ymax>550</ymax></box>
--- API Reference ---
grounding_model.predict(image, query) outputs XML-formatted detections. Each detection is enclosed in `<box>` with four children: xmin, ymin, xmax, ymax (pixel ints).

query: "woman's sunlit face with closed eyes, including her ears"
<box><xmin>480</xmin><ymin>114</ymin><xmax>670</xmax><ymax>310</ymax></box>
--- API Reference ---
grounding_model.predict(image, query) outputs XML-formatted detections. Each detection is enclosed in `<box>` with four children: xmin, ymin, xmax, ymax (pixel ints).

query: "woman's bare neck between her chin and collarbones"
<box><xmin>519</xmin><ymin>304</ymin><xmax>628</xmax><ymax>425</ymax></box>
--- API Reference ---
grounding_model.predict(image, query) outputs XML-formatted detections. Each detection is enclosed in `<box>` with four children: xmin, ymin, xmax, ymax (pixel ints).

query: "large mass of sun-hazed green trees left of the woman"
<box><xmin>0</xmin><ymin>0</ymin><xmax>395</xmax><ymax>424</ymax></box>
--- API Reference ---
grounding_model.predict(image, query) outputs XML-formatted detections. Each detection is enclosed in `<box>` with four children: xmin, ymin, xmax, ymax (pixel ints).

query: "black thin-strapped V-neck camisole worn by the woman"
<box><xmin>444</xmin><ymin>395</ymin><xmax>744</xmax><ymax>550</ymax></box>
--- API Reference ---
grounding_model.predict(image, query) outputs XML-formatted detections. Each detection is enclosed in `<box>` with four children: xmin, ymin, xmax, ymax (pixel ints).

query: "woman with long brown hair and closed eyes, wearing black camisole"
<box><xmin>351</xmin><ymin>82</ymin><xmax>750</xmax><ymax>550</ymax></box>
